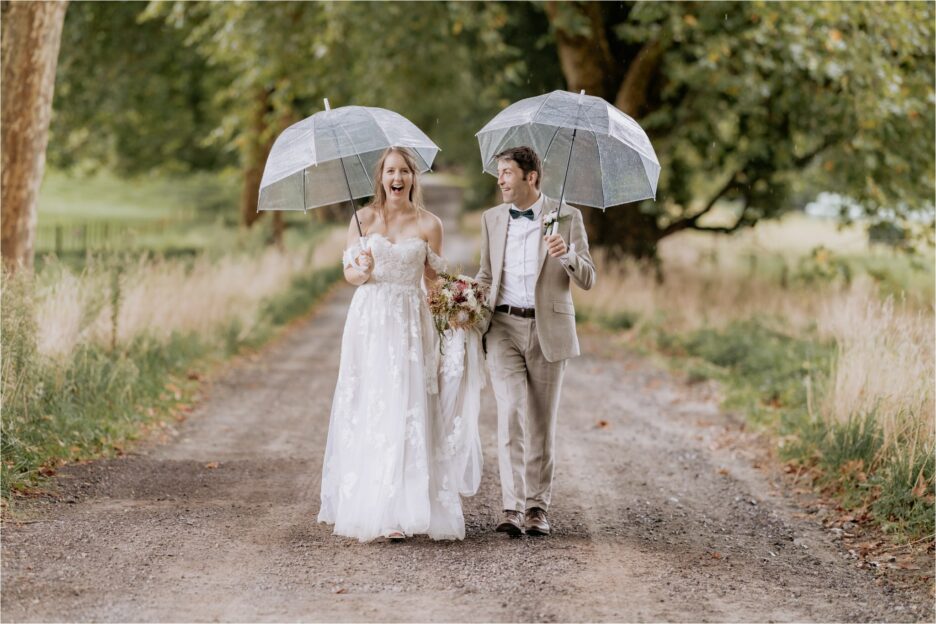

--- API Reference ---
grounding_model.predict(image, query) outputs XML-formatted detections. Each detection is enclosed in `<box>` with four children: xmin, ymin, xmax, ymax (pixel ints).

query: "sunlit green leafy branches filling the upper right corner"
<box><xmin>644</xmin><ymin>2</ymin><xmax>936</xmax><ymax>232</ymax></box>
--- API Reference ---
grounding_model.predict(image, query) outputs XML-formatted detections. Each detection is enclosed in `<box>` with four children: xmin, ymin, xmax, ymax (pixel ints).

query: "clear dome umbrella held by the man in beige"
<box><xmin>476</xmin><ymin>91</ymin><xmax>660</xmax><ymax>228</ymax></box>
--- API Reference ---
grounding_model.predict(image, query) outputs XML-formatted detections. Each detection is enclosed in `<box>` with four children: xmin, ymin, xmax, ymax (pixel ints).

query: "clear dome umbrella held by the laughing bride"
<box><xmin>257</xmin><ymin>99</ymin><xmax>439</xmax><ymax>233</ymax></box>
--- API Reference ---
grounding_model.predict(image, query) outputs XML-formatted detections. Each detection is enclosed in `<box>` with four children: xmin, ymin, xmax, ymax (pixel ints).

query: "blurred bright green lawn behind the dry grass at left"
<box><xmin>36</xmin><ymin>170</ymin><xmax>323</xmax><ymax>267</ymax></box>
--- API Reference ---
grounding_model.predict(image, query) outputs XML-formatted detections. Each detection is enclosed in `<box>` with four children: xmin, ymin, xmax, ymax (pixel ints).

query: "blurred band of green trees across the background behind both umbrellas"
<box><xmin>11</xmin><ymin>2</ymin><xmax>934</xmax><ymax>258</ymax></box>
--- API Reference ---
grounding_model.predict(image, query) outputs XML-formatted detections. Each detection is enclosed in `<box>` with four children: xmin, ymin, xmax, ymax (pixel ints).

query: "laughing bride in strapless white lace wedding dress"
<box><xmin>318</xmin><ymin>147</ymin><xmax>483</xmax><ymax>541</ymax></box>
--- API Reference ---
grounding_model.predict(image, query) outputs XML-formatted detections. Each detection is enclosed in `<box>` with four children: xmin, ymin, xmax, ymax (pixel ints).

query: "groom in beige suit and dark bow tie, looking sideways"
<box><xmin>477</xmin><ymin>147</ymin><xmax>595</xmax><ymax>535</ymax></box>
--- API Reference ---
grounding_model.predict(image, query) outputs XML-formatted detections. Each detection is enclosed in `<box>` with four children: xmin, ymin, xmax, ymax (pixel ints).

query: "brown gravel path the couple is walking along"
<box><xmin>2</xmin><ymin>238</ymin><xmax>933</xmax><ymax>621</ymax></box>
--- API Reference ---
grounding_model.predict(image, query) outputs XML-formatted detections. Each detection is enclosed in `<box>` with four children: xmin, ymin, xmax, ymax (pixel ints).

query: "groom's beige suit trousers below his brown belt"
<box><xmin>486</xmin><ymin>312</ymin><xmax>567</xmax><ymax>511</ymax></box>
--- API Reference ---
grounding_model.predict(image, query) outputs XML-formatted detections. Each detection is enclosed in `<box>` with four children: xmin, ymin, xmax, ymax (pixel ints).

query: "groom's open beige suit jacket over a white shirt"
<box><xmin>477</xmin><ymin>197</ymin><xmax>595</xmax><ymax>362</ymax></box>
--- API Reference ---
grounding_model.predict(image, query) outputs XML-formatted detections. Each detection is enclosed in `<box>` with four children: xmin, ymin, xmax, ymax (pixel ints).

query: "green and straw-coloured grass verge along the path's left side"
<box><xmin>0</xmin><ymin>247</ymin><xmax>341</xmax><ymax>502</ymax></box>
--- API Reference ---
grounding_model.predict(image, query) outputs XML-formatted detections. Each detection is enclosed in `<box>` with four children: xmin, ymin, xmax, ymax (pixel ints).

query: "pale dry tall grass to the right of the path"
<box><xmin>575</xmin><ymin>217</ymin><xmax>936</xmax><ymax>464</ymax></box>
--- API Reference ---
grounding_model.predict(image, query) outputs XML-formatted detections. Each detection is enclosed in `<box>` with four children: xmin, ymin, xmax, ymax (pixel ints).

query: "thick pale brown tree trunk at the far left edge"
<box><xmin>0</xmin><ymin>1</ymin><xmax>68</xmax><ymax>270</ymax></box>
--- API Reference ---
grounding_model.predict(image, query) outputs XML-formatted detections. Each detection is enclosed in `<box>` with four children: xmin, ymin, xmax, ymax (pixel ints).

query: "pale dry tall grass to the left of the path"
<box><xmin>36</xmin><ymin>231</ymin><xmax>344</xmax><ymax>358</ymax></box>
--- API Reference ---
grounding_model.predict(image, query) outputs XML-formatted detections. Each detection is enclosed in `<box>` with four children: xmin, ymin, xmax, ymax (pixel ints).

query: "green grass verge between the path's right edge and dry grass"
<box><xmin>624</xmin><ymin>317</ymin><xmax>936</xmax><ymax>542</ymax></box>
